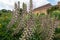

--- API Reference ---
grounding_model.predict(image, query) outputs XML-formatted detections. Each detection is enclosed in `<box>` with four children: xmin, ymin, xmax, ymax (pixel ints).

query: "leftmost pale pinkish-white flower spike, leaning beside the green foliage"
<box><xmin>7</xmin><ymin>3</ymin><xmax>19</xmax><ymax>30</ymax></box>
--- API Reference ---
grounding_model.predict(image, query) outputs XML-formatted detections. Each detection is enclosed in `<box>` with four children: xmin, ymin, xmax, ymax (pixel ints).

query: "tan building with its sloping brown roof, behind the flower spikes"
<box><xmin>33</xmin><ymin>4</ymin><xmax>51</xmax><ymax>15</ymax></box>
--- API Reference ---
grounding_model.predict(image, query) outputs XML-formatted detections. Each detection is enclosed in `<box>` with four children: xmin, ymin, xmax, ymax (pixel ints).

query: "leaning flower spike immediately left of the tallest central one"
<box><xmin>12</xmin><ymin>2</ymin><xmax>27</xmax><ymax>35</ymax></box>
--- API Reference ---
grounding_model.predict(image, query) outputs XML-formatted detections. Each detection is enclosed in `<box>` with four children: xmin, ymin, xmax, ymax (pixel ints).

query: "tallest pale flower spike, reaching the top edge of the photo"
<box><xmin>19</xmin><ymin>0</ymin><xmax>34</xmax><ymax>40</ymax></box>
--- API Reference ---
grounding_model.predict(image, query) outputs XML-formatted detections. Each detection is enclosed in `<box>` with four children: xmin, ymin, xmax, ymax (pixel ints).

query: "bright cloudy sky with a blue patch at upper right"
<box><xmin>0</xmin><ymin>0</ymin><xmax>60</xmax><ymax>10</ymax></box>
